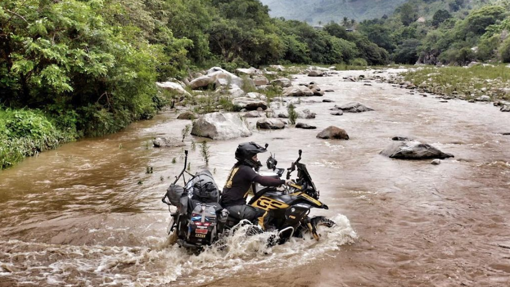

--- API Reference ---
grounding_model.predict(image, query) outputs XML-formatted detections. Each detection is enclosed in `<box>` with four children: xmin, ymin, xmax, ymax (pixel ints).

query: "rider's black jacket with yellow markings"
<box><xmin>220</xmin><ymin>163</ymin><xmax>285</xmax><ymax>207</ymax></box>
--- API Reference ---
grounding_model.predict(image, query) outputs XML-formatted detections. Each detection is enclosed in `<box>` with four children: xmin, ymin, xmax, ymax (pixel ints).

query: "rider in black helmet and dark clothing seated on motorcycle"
<box><xmin>220</xmin><ymin>142</ymin><xmax>287</xmax><ymax>232</ymax></box>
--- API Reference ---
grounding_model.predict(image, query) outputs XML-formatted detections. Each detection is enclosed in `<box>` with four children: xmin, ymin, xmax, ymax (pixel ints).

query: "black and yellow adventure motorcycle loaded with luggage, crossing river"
<box><xmin>162</xmin><ymin>147</ymin><xmax>335</xmax><ymax>251</ymax></box>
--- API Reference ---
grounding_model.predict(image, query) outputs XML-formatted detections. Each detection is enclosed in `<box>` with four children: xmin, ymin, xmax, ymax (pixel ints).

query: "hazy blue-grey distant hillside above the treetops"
<box><xmin>261</xmin><ymin>0</ymin><xmax>406</xmax><ymax>24</ymax></box>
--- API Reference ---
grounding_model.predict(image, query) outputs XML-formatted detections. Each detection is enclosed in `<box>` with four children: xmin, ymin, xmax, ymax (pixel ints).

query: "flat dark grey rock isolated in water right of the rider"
<box><xmin>381</xmin><ymin>141</ymin><xmax>453</xmax><ymax>159</ymax></box>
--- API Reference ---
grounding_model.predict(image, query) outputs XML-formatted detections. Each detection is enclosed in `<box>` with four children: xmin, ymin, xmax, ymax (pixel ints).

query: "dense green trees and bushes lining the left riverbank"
<box><xmin>0</xmin><ymin>0</ymin><xmax>388</xmax><ymax>168</ymax></box>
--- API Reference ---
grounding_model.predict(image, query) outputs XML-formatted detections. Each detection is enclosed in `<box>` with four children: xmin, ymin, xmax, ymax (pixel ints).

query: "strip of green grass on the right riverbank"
<box><xmin>402</xmin><ymin>65</ymin><xmax>510</xmax><ymax>101</ymax></box>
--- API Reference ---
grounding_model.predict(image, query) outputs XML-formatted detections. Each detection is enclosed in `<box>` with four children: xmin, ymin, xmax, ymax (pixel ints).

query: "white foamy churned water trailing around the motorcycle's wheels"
<box><xmin>0</xmin><ymin>214</ymin><xmax>357</xmax><ymax>286</ymax></box>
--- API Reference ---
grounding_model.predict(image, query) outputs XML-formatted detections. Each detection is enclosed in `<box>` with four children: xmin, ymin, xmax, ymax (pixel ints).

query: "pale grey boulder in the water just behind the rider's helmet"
<box><xmin>191</xmin><ymin>112</ymin><xmax>252</xmax><ymax>140</ymax></box>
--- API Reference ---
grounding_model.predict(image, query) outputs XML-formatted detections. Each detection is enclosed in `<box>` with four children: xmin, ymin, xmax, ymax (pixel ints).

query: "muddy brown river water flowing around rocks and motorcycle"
<box><xmin>0</xmin><ymin>71</ymin><xmax>510</xmax><ymax>287</ymax></box>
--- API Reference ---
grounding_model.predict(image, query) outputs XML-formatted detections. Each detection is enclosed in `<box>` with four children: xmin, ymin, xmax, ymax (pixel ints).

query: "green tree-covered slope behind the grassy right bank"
<box><xmin>356</xmin><ymin>0</ymin><xmax>510</xmax><ymax>65</ymax></box>
